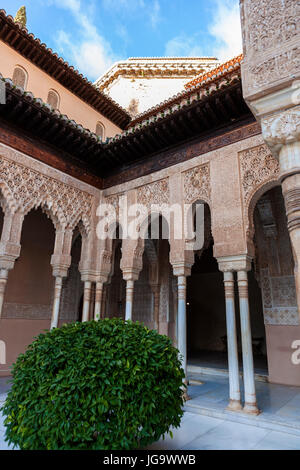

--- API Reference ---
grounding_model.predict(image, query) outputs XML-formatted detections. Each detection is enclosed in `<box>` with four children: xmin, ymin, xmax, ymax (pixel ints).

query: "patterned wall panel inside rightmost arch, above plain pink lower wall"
<box><xmin>260</xmin><ymin>268</ymin><xmax>299</xmax><ymax>325</ymax></box>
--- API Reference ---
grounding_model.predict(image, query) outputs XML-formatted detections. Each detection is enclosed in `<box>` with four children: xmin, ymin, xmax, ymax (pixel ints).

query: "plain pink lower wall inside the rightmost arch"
<box><xmin>266</xmin><ymin>325</ymin><xmax>300</xmax><ymax>386</ymax></box>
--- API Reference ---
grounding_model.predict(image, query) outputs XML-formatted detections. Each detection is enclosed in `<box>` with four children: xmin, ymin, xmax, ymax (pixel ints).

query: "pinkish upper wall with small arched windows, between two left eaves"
<box><xmin>0</xmin><ymin>41</ymin><xmax>120</xmax><ymax>137</ymax></box>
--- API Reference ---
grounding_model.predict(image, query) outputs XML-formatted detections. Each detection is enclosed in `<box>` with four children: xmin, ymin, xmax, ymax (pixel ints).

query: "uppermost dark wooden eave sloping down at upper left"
<box><xmin>0</xmin><ymin>10</ymin><xmax>131</xmax><ymax>129</ymax></box>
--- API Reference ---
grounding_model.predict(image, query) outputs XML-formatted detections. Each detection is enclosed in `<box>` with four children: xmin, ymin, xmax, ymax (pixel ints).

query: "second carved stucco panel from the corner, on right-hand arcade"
<box><xmin>137</xmin><ymin>178</ymin><xmax>170</xmax><ymax>208</ymax></box>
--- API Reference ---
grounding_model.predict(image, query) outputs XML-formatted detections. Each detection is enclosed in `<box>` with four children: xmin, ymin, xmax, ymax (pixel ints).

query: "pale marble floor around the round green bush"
<box><xmin>0</xmin><ymin>376</ymin><xmax>300</xmax><ymax>450</ymax></box>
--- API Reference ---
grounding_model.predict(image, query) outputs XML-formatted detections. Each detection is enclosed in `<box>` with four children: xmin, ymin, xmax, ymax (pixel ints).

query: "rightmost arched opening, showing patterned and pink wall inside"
<box><xmin>249</xmin><ymin>186</ymin><xmax>300</xmax><ymax>386</ymax></box>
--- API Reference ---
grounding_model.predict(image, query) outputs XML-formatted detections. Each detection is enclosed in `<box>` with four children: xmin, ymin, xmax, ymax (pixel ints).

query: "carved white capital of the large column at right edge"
<box><xmin>261</xmin><ymin>106</ymin><xmax>300</xmax><ymax>151</ymax></box>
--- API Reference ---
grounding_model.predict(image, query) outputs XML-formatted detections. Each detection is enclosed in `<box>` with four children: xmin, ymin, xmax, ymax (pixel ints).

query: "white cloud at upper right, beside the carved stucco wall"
<box><xmin>165</xmin><ymin>0</ymin><xmax>242</xmax><ymax>62</ymax></box>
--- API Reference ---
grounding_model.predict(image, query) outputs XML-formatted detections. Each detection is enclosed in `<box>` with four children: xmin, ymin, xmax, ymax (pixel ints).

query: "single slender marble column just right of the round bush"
<box><xmin>178</xmin><ymin>276</ymin><xmax>187</xmax><ymax>379</ymax></box>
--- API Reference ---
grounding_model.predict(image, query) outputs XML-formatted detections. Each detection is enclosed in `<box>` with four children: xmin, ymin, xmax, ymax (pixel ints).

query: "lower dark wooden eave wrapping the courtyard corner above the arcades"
<box><xmin>0</xmin><ymin>76</ymin><xmax>259</xmax><ymax>187</ymax></box>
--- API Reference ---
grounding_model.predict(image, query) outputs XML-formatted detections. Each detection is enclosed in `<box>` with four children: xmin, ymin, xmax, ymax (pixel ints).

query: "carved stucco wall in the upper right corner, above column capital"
<box><xmin>240</xmin><ymin>0</ymin><xmax>300</xmax><ymax>98</ymax></box>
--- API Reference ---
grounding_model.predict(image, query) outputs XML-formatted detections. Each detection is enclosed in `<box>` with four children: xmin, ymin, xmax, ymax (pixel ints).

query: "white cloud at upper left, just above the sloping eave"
<box><xmin>49</xmin><ymin>0</ymin><xmax>119</xmax><ymax>79</ymax></box>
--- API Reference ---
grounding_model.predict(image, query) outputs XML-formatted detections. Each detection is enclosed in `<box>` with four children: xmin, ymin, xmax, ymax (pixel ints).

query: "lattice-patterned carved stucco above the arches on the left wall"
<box><xmin>0</xmin><ymin>157</ymin><xmax>93</xmax><ymax>232</ymax></box>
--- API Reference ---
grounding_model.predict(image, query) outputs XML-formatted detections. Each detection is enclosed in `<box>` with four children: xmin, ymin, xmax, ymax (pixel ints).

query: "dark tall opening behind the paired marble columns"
<box><xmin>187</xmin><ymin>200</ymin><xmax>268</xmax><ymax>376</ymax></box>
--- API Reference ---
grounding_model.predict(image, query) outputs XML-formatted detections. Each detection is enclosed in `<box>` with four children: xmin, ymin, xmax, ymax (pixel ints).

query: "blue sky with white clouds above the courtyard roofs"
<box><xmin>0</xmin><ymin>0</ymin><xmax>241</xmax><ymax>80</ymax></box>
